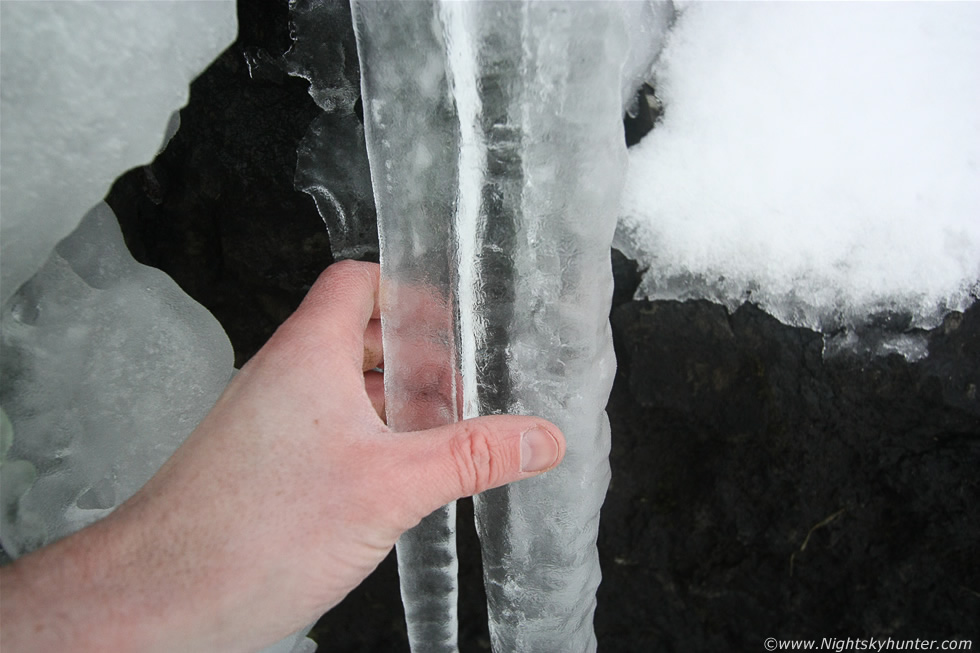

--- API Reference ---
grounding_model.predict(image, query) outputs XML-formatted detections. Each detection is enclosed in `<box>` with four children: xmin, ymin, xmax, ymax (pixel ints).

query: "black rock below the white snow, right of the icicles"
<box><xmin>596</xmin><ymin>302</ymin><xmax>980</xmax><ymax>651</ymax></box>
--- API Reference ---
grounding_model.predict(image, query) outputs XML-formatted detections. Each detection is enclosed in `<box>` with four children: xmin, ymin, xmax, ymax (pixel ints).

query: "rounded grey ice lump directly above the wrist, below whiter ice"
<box><xmin>0</xmin><ymin>203</ymin><xmax>233</xmax><ymax>556</ymax></box>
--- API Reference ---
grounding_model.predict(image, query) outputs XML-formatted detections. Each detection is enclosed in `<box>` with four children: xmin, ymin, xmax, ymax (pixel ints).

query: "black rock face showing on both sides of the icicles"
<box><xmin>109</xmin><ymin>0</ymin><xmax>980</xmax><ymax>652</ymax></box>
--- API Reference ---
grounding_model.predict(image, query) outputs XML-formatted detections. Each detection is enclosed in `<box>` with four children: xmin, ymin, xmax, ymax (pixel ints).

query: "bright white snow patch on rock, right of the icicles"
<box><xmin>617</xmin><ymin>3</ymin><xmax>980</xmax><ymax>332</ymax></box>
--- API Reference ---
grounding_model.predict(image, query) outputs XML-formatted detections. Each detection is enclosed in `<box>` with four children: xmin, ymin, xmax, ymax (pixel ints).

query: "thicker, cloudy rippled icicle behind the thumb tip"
<box><xmin>453</xmin><ymin>3</ymin><xmax>629</xmax><ymax>651</ymax></box>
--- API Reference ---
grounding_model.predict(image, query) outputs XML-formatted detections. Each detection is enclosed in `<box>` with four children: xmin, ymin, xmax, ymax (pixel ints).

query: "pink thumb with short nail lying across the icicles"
<box><xmin>400</xmin><ymin>415</ymin><xmax>565</xmax><ymax>510</ymax></box>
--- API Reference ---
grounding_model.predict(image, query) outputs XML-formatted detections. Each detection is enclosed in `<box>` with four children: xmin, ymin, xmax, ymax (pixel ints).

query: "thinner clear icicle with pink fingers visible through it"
<box><xmin>352</xmin><ymin>2</ymin><xmax>468</xmax><ymax>653</ymax></box>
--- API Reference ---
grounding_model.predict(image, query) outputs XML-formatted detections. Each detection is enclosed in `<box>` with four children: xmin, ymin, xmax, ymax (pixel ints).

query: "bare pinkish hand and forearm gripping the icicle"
<box><xmin>0</xmin><ymin>262</ymin><xmax>565</xmax><ymax>653</ymax></box>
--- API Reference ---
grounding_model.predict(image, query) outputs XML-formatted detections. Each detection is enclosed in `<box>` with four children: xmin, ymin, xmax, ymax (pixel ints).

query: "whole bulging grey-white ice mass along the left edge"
<box><xmin>0</xmin><ymin>6</ymin><xmax>316</xmax><ymax>653</ymax></box>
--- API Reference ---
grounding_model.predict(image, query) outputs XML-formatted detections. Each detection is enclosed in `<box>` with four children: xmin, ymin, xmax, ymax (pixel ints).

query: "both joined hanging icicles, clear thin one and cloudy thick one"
<box><xmin>353</xmin><ymin>0</ymin><xmax>673</xmax><ymax>651</ymax></box>
